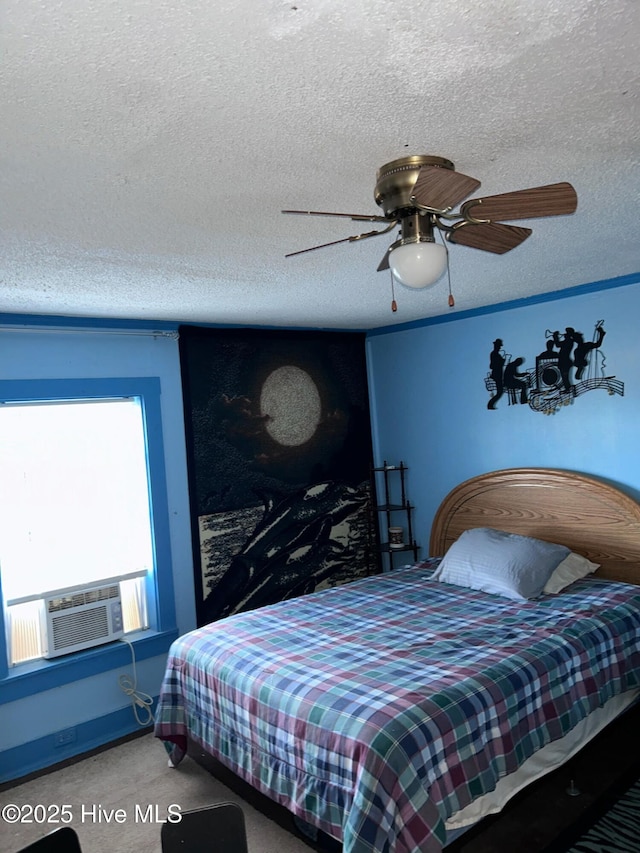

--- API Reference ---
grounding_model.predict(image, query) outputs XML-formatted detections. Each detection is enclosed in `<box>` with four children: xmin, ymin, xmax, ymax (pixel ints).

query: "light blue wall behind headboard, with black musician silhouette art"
<box><xmin>367</xmin><ymin>276</ymin><xmax>640</xmax><ymax>556</ymax></box>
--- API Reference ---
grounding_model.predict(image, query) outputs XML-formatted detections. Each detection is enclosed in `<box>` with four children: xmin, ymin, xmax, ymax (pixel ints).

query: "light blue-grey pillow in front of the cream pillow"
<box><xmin>432</xmin><ymin>527</ymin><xmax>571</xmax><ymax>601</ymax></box>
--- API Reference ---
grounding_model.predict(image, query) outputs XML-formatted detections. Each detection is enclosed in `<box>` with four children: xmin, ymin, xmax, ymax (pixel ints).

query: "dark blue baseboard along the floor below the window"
<box><xmin>0</xmin><ymin>697</ymin><xmax>157</xmax><ymax>787</ymax></box>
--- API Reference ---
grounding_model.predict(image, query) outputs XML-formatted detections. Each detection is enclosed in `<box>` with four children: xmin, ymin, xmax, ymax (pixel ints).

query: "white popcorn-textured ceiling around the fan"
<box><xmin>0</xmin><ymin>0</ymin><xmax>640</xmax><ymax>329</ymax></box>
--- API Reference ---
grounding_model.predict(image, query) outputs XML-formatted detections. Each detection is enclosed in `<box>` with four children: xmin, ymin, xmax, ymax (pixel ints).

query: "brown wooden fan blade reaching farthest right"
<box><xmin>460</xmin><ymin>181</ymin><xmax>578</xmax><ymax>221</ymax></box>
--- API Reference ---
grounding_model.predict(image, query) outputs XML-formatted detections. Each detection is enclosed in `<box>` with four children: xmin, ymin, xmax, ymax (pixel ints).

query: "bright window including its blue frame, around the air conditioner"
<box><xmin>0</xmin><ymin>377</ymin><xmax>176</xmax><ymax>698</ymax></box>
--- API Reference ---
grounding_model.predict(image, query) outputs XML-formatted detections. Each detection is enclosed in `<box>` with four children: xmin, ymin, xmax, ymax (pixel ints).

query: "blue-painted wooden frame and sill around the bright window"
<box><xmin>0</xmin><ymin>376</ymin><xmax>178</xmax><ymax>702</ymax></box>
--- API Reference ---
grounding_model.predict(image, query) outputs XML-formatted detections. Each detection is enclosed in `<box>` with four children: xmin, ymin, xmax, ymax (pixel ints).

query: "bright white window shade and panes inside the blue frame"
<box><xmin>0</xmin><ymin>397</ymin><xmax>152</xmax><ymax>664</ymax></box>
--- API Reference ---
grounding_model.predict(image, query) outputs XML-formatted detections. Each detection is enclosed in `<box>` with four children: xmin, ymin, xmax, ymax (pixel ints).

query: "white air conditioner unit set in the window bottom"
<box><xmin>42</xmin><ymin>581</ymin><xmax>124</xmax><ymax>658</ymax></box>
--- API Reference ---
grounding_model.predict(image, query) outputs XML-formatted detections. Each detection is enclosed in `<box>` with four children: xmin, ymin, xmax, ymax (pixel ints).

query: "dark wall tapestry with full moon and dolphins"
<box><xmin>180</xmin><ymin>326</ymin><xmax>377</xmax><ymax>625</ymax></box>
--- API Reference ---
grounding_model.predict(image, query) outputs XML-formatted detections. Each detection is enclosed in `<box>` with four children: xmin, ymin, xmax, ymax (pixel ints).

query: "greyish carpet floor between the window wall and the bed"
<box><xmin>0</xmin><ymin>734</ymin><xmax>310</xmax><ymax>853</ymax></box>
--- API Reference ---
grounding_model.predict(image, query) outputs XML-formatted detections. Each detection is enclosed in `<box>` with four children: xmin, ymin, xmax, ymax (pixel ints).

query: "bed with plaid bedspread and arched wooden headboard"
<box><xmin>155</xmin><ymin>468</ymin><xmax>640</xmax><ymax>853</ymax></box>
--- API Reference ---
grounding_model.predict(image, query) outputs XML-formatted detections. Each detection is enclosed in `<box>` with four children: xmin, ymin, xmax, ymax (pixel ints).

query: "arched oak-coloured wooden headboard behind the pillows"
<box><xmin>429</xmin><ymin>468</ymin><xmax>640</xmax><ymax>584</ymax></box>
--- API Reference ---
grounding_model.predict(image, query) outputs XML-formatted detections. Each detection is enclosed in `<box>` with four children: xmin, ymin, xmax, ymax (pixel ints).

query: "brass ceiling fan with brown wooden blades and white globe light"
<box><xmin>282</xmin><ymin>154</ymin><xmax>578</xmax><ymax>311</ymax></box>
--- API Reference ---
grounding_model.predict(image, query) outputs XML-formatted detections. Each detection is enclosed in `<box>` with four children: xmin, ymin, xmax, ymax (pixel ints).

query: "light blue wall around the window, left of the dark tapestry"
<box><xmin>0</xmin><ymin>317</ymin><xmax>195</xmax><ymax>779</ymax></box>
